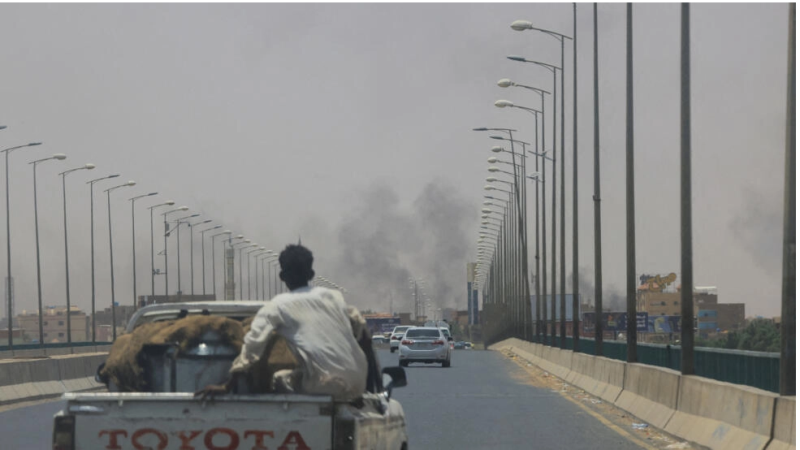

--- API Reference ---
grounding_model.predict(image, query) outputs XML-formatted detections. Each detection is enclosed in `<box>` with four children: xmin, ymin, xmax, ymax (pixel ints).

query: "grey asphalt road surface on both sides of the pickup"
<box><xmin>0</xmin><ymin>350</ymin><xmax>641</xmax><ymax>450</ymax></box>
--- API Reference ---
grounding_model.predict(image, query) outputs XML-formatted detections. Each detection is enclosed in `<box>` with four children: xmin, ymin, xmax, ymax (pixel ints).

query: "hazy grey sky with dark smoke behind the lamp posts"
<box><xmin>0</xmin><ymin>3</ymin><xmax>788</xmax><ymax>316</ymax></box>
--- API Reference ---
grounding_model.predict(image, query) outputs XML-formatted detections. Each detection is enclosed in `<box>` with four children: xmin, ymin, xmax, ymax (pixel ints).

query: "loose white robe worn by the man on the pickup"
<box><xmin>231</xmin><ymin>287</ymin><xmax>367</xmax><ymax>400</ymax></box>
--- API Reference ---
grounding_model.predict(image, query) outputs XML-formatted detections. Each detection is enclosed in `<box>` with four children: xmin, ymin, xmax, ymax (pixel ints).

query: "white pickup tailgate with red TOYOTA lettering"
<box><xmin>64</xmin><ymin>393</ymin><xmax>334</xmax><ymax>450</ymax></box>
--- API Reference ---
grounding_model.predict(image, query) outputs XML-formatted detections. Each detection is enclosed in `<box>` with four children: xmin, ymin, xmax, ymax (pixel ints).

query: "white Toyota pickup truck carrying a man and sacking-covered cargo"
<box><xmin>53</xmin><ymin>301</ymin><xmax>408</xmax><ymax>450</ymax></box>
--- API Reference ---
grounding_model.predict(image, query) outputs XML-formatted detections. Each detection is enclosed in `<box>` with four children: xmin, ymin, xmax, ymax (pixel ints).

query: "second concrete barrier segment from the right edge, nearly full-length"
<box><xmin>664</xmin><ymin>375</ymin><xmax>778</xmax><ymax>450</ymax></box>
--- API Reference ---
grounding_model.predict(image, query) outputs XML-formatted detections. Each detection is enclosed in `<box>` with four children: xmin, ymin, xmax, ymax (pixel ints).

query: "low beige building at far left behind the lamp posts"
<box><xmin>16</xmin><ymin>306</ymin><xmax>91</xmax><ymax>344</ymax></box>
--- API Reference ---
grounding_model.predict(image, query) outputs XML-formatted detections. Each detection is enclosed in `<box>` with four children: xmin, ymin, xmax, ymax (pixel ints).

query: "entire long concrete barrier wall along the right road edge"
<box><xmin>489</xmin><ymin>338</ymin><xmax>796</xmax><ymax>450</ymax></box>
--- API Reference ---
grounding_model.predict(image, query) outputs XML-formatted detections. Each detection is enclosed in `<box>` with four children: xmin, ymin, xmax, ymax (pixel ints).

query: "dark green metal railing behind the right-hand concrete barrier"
<box><xmin>536</xmin><ymin>337</ymin><xmax>780</xmax><ymax>393</ymax></box>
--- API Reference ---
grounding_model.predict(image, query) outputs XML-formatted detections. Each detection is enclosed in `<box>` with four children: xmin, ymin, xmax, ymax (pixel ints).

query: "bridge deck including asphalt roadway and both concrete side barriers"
<box><xmin>0</xmin><ymin>338</ymin><xmax>796</xmax><ymax>450</ymax></box>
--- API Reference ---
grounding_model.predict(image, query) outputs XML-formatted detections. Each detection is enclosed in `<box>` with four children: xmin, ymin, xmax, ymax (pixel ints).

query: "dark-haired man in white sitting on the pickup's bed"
<box><xmin>198</xmin><ymin>245</ymin><xmax>367</xmax><ymax>400</ymax></box>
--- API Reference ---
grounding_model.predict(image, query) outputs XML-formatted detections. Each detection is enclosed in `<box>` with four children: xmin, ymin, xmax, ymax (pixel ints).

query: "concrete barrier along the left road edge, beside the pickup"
<box><xmin>0</xmin><ymin>353</ymin><xmax>107</xmax><ymax>404</ymax></box>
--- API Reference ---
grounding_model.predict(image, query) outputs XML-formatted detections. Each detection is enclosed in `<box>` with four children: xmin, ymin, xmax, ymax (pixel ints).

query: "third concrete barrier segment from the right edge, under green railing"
<box><xmin>614</xmin><ymin>364</ymin><xmax>681</xmax><ymax>429</ymax></box>
